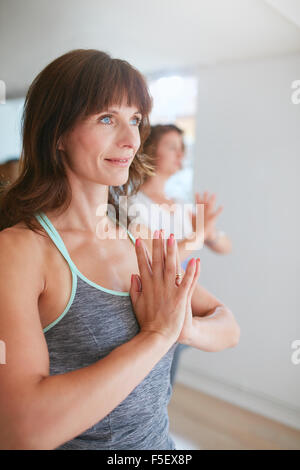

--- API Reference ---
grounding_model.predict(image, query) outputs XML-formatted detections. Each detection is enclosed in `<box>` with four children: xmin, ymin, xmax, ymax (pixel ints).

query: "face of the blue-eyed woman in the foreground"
<box><xmin>59</xmin><ymin>102</ymin><xmax>142</xmax><ymax>186</ymax></box>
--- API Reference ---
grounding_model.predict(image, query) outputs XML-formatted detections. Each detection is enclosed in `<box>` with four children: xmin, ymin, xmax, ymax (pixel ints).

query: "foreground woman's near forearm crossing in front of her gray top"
<box><xmin>9</xmin><ymin>332</ymin><xmax>172</xmax><ymax>449</ymax></box>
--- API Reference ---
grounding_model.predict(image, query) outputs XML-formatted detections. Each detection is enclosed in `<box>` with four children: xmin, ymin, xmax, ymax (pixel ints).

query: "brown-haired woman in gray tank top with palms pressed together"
<box><xmin>0</xmin><ymin>50</ymin><xmax>240</xmax><ymax>450</ymax></box>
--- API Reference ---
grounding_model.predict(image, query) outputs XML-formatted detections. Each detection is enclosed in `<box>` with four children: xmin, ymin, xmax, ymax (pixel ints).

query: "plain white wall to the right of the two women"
<box><xmin>178</xmin><ymin>51</ymin><xmax>300</xmax><ymax>428</ymax></box>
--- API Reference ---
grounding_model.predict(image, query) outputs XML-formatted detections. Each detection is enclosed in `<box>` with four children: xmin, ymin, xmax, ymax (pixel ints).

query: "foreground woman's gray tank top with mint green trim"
<box><xmin>35</xmin><ymin>212</ymin><xmax>178</xmax><ymax>450</ymax></box>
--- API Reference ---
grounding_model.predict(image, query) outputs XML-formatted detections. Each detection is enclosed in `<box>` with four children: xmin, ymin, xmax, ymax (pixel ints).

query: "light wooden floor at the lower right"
<box><xmin>168</xmin><ymin>383</ymin><xmax>300</xmax><ymax>450</ymax></box>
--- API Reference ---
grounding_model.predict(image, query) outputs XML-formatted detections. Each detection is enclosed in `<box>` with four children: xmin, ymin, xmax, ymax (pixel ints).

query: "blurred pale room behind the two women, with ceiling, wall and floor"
<box><xmin>0</xmin><ymin>0</ymin><xmax>300</xmax><ymax>449</ymax></box>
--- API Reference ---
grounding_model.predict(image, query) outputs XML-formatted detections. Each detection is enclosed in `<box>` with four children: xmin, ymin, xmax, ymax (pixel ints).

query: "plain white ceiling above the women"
<box><xmin>0</xmin><ymin>0</ymin><xmax>300</xmax><ymax>98</ymax></box>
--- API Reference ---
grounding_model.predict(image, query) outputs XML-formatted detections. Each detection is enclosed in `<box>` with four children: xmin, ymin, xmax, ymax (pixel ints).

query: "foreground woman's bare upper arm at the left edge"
<box><xmin>0</xmin><ymin>229</ymin><xmax>49</xmax><ymax>443</ymax></box>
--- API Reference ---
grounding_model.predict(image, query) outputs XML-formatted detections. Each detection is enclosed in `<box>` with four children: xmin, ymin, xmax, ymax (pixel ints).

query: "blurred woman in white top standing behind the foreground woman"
<box><xmin>128</xmin><ymin>124</ymin><xmax>231</xmax><ymax>385</ymax></box>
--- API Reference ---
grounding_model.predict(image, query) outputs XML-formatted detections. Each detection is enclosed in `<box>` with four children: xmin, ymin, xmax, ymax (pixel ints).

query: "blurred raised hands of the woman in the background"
<box><xmin>190</xmin><ymin>191</ymin><xmax>224</xmax><ymax>242</ymax></box>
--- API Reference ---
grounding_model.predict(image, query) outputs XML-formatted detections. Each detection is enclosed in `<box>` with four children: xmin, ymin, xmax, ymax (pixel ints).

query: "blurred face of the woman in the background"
<box><xmin>156</xmin><ymin>131</ymin><xmax>184</xmax><ymax>176</ymax></box>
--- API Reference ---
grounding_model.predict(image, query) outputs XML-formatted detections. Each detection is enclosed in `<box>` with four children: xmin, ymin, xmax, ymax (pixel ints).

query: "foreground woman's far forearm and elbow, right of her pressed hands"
<box><xmin>186</xmin><ymin>305</ymin><xmax>240</xmax><ymax>352</ymax></box>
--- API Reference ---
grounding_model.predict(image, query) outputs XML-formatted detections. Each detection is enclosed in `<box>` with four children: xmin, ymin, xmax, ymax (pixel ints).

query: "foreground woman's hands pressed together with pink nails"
<box><xmin>130</xmin><ymin>230</ymin><xmax>199</xmax><ymax>343</ymax></box>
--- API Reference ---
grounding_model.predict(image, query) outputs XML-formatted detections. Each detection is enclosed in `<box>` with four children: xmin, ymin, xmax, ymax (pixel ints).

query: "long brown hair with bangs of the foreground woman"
<box><xmin>0</xmin><ymin>49</ymin><xmax>155</xmax><ymax>233</ymax></box>
